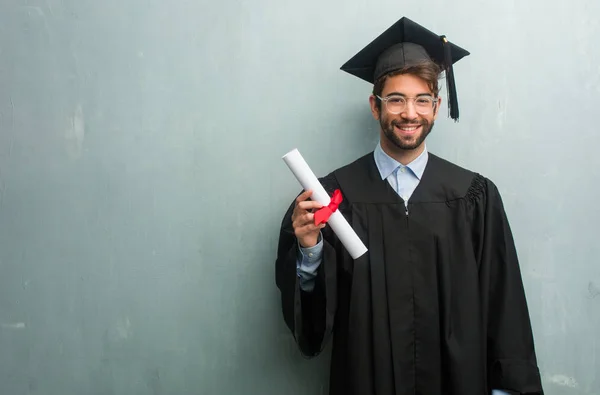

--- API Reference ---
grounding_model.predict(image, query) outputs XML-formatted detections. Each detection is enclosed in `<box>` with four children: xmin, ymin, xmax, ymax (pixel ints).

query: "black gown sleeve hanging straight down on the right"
<box><xmin>470</xmin><ymin>176</ymin><xmax>544</xmax><ymax>395</ymax></box>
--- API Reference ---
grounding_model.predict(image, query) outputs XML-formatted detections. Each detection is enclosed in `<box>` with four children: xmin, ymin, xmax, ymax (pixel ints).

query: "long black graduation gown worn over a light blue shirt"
<box><xmin>276</xmin><ymin>153</ymin><xmax>543</xmax><ymax>395</ymax></box>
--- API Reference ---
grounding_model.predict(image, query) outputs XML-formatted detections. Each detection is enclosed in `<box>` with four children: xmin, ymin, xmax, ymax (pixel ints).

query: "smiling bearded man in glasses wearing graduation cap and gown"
<box><xmin>276</xmin><ymin>18</ymin><xmax>543</xmax><ymax>395</ymax></box>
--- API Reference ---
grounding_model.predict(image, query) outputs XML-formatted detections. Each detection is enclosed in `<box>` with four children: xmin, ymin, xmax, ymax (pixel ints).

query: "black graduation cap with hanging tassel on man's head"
<box><xmin>341</xmin><ymin>17</ymin><xmax>469</xmax><ymax>120</ymax></box>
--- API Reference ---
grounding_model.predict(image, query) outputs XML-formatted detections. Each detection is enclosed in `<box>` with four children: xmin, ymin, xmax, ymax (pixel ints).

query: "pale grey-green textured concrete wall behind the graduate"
<box><xmin>0</xmin><ymin>0</ymin><xmax>600</xmax><ymax>395</ymax></box>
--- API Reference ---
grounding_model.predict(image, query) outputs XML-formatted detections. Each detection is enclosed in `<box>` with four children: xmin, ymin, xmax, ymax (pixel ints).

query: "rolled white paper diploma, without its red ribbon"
<box><xmin>282</xmin><ymin>149</ymin><xmax>367</xmax><ymax>259</ymax></box>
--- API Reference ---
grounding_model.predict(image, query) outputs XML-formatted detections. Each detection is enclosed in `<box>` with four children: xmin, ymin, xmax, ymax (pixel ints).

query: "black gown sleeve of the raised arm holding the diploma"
<box><xmin>275</xmin><ymin>175</ymin><xmax>342</xmax><ymax>357</ymax></box>
